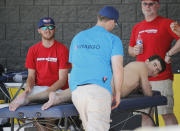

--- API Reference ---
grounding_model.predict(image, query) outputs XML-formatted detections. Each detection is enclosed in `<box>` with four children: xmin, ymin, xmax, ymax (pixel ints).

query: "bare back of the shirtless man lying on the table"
<box><xmin>121</xmin><ymin>62</ymin><xmax>148</xmax><ymax>97</ymax></box>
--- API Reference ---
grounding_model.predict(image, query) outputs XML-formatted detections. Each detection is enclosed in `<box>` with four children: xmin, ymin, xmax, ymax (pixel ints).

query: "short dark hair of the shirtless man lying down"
<box><xmin>148</xmin><ymin>55</ymin><xmax>166</xmax><ymax>73</ymax></box>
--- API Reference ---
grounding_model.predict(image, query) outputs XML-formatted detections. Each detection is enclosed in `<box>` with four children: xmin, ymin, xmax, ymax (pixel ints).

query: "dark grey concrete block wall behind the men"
<box><xmin>0</xmin><ymin>0</ymin><xmax>180</xmax><ymax>71</ymax></box>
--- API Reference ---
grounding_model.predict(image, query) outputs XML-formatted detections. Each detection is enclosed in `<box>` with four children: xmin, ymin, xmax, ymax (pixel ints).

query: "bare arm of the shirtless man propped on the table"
<box><xmin>140</xmin><ymin>68</ymin><xmax>152</xmax><ymax>96</ymax></box>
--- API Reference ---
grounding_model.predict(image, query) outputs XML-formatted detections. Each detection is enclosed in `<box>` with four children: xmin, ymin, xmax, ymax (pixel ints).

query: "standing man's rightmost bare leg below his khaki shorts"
<box><xmin>162</xmin><ymin>113</ymin><xmax>178</xmax><ymax>125</ymax></box>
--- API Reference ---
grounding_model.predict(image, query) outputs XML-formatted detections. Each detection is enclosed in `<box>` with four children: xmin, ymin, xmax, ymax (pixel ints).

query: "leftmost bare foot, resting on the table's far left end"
<box><xmin>9</xmin><ymin>91</ymin><xmax>29</xmax><ymax>111</ymax></box>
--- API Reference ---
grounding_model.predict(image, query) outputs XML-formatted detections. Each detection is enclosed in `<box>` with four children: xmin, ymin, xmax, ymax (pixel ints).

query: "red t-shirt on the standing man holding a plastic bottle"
<box><xmin>129</xmin><ymin>16</ymin><xmax>179</xmax><ymax>81</ymax></box>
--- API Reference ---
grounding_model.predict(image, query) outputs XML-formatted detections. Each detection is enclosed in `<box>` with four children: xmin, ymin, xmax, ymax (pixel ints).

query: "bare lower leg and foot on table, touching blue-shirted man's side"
<box><xmin>41</xmin><ymin>89</ymin><xmax>71</xmax><ymax>110</ymax></box>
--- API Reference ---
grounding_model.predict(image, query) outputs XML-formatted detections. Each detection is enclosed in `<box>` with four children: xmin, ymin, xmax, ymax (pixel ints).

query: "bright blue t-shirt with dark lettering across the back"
<box><xmin>69</xmin><ymin>26</ymin><xmax>123</xmax><ymax>94</ymax></box>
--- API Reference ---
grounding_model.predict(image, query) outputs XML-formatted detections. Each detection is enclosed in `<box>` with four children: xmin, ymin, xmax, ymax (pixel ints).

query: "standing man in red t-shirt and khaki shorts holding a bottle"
<box><xmin>128</xmin><ymin>0</ymin><xmax>180</xmax><ymax>126</ymax></box>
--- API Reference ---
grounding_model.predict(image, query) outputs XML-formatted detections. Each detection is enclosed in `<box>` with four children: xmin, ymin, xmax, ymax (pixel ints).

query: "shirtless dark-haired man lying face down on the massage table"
<box><xmin>42</xmin><ymin>55</ymin><xmax>166</xmax><ymax>110</ymax></box>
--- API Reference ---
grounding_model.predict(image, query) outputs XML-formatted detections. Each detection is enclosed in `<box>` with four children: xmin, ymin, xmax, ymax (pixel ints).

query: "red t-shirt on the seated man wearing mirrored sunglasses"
<box><xmin>25</xmin><ymin>41</ymin><xmax>71</xmax><ymax>89</ymax></box>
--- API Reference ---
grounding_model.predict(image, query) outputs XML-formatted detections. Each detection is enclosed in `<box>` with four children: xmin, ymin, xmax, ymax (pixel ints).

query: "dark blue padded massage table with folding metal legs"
<box><xmin>0</xmin><ymin>72</ymin><xmax>167</xmax><ymax>131</ymax></box>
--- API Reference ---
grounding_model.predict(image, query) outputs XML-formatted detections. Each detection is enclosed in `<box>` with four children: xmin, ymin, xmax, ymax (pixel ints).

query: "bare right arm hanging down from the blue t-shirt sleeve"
<box><xmin>111</xmin><ymin>55</ymin><xmax>123</xmax><ymax>109</ymax></box>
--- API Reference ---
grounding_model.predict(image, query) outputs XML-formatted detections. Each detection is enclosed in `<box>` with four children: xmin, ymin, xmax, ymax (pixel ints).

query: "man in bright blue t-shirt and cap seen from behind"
<box><xmin>69</xmin><ymin>6</ymin><xmax>123</xmax><ymax>131</ymax></box>
